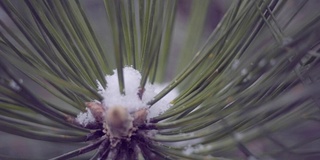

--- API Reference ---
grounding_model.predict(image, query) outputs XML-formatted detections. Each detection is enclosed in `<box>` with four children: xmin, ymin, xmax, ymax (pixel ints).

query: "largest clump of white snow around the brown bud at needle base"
<box><xmin>77</xmin><ymin>67</ymin><xmax>179</xmax><ymax>124</ymax></box>
